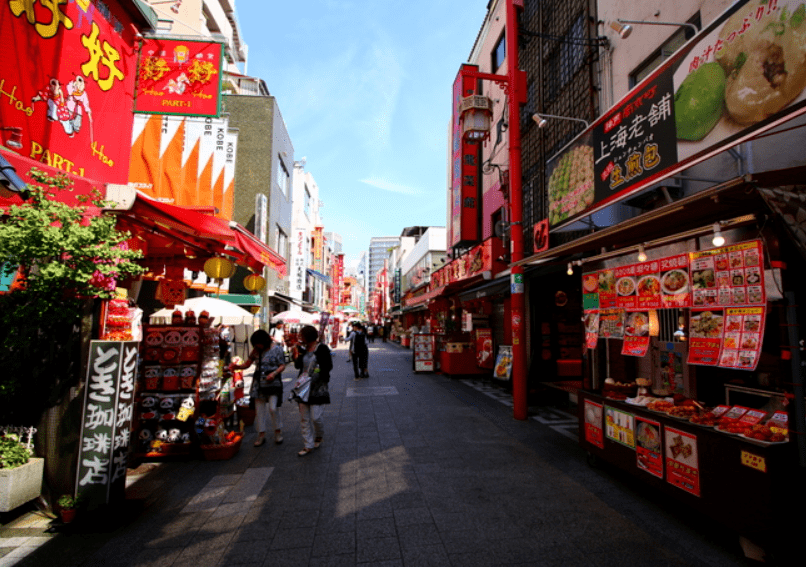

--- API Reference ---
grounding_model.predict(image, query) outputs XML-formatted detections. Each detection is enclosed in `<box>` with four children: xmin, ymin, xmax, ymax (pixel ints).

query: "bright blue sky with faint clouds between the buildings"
<box><xmin>236</xmin><ymin>0</ymin><xmax>489</xmax><ymax>263</ymax></box>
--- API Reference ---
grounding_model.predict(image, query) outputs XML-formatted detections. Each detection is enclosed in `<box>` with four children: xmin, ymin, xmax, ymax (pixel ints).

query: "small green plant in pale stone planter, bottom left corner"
<box><xmin>0</xmin><ymin>432</ymin><xmax>45</xmax><ymax>512</ymax></box>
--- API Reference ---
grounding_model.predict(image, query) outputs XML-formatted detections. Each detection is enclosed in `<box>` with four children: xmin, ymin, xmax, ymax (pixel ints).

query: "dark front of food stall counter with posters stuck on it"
<box><xmin>579</xmin><ymin>390</ymin><xmax>797</xmax><ymax>546</ymax></box>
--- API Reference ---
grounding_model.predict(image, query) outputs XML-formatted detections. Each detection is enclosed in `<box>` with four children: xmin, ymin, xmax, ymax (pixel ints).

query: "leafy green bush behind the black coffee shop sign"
<box><xmin>0</xmin><ymin>169</ymin><xmax>143</xmax><ymax>424</ymax></box>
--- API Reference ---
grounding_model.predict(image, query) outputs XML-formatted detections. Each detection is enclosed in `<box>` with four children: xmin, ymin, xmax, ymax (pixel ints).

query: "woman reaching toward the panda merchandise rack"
<box><xmin>229</xmin><ymin>329</ymin><xmax>285</xmax><ymax>447</ymax></box>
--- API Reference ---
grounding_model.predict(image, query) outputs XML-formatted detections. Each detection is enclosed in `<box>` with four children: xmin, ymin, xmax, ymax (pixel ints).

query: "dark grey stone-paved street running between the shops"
<box><xmin>0</xmin><ymin>341</ymin><xmax>751</xmax><ymax>567</ymax></box>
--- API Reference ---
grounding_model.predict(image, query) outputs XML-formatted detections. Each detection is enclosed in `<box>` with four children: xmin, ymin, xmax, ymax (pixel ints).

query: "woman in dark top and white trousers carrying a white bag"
<box><xmin>291</xmin><ymin>325</ymin><xmax>333</xmax><ymax>457</ymax></box>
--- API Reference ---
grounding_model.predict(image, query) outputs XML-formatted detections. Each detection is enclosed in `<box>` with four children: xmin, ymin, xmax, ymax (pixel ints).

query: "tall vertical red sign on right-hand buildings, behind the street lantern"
<box><xmin>448</xmin><ymin>65</ymin><xmax>480</xmax><ymax>247</ymax></box>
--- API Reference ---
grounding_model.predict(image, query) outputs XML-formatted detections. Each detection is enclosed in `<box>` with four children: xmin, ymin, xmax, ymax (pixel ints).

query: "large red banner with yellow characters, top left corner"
<box><xmin>0</xmin><ymin>1</ymin><xmax>137</xmax><ymax>184</ymax></box>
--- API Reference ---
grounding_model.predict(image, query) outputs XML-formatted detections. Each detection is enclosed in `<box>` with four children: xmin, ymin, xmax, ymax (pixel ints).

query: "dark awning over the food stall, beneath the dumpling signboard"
<box><xmin>518</xmin><ymin>167</ymin><xmax>806</xmax><ymax>265</ymax></box>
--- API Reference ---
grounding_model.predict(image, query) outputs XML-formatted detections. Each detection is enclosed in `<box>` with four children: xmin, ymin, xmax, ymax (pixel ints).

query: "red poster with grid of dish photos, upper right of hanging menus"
<box><xmin>691</xmin><ymin>240</ymin><xmax>767</xmax><ymax>307</ymax></box>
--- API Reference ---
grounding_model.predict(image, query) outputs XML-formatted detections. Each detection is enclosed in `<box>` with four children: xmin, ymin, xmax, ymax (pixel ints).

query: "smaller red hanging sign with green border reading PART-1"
<box><xmin>134</xmin><ymin>38</ymin><xmax>224</xmax><ymax>116</ymax></box>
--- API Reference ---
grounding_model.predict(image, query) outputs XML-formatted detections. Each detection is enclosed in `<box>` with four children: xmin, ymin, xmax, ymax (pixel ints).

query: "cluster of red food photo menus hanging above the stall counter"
<box><xmin>582</xmin><ymin>240</ymin><xmax>767</xmax><ymax>370</ymax></box>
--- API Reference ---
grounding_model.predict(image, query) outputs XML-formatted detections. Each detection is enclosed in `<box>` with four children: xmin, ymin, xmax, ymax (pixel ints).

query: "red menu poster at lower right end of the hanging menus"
<box><xmin>719</xmin><ymin>307</ymin><xmax>767</xmax><ymax>370</ymax></box>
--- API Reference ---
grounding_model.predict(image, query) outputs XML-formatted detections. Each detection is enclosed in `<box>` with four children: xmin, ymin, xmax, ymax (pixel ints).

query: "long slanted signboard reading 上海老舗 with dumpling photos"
<box><xmin>547</xmin><ymin>0</ymin><xmax>806</xmax><ymax>227</ymax></box>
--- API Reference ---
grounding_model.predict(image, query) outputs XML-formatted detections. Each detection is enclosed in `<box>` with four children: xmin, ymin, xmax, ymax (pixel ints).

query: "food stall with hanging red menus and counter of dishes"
<box><xmin>579</xmin><ymin>222</ymin><xmax>802</xmax><ymax>548</ymax></box>
